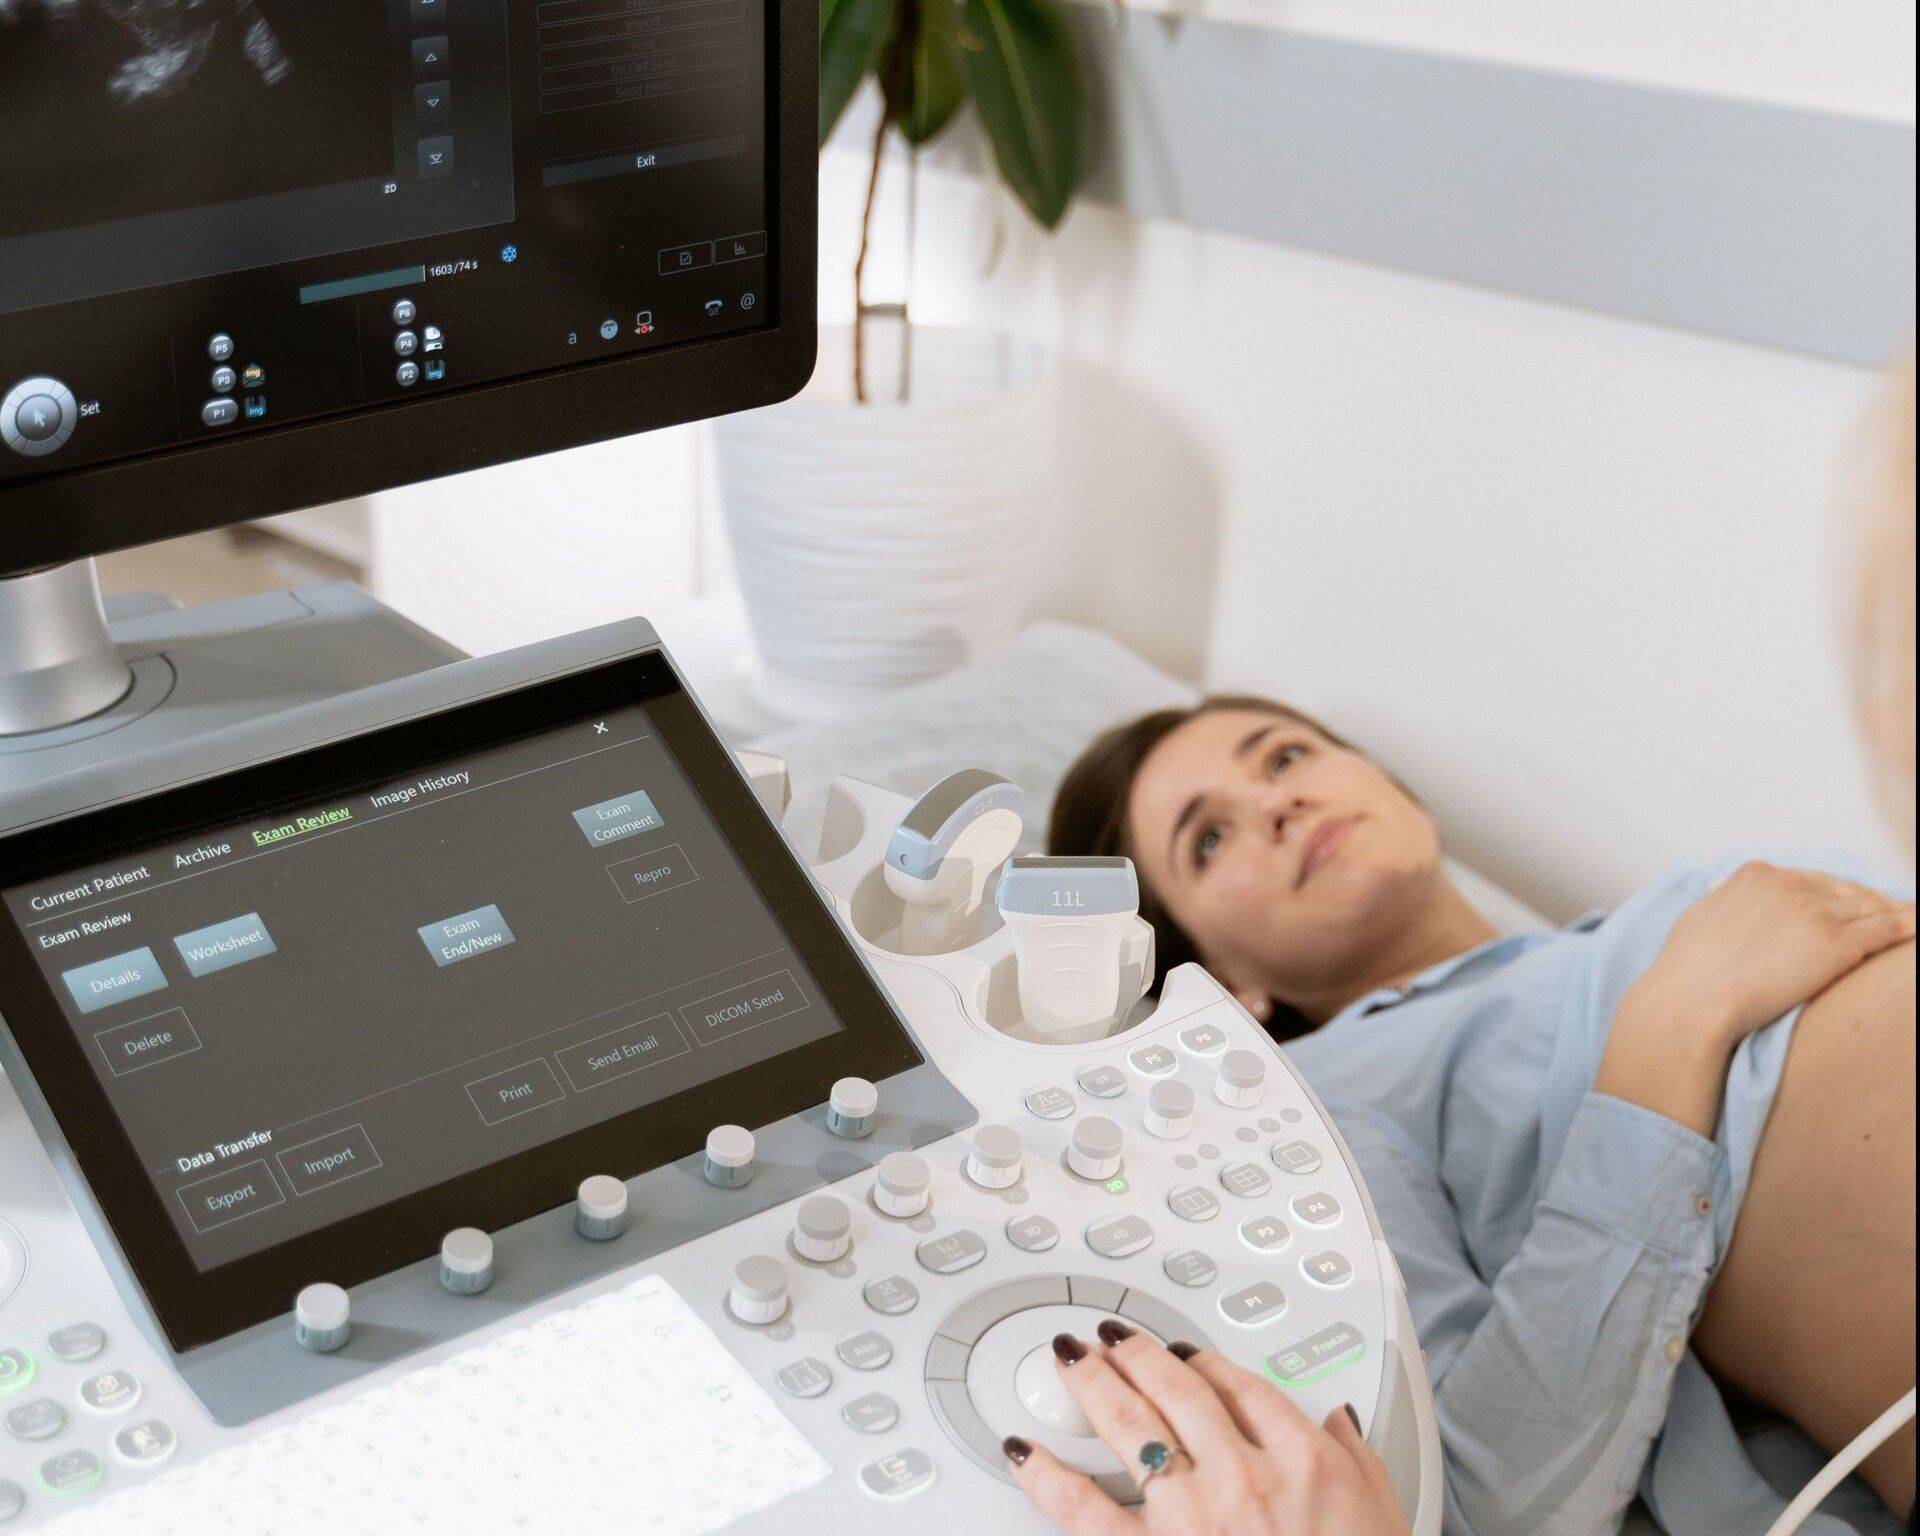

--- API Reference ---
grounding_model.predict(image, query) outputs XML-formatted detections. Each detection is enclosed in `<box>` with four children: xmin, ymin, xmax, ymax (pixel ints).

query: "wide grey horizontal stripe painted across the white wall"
<box><xmin>840</xmin><ymin>14</ymin><xmax>1914</xmax><ymax>365</ymax></box>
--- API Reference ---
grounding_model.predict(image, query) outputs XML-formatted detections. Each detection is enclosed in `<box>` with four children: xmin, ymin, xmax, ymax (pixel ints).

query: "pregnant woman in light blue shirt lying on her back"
<box><xmin>1050</xmin><ymin>699</ymin><xmax>1914</xmax><ymax>1536</ymax></box>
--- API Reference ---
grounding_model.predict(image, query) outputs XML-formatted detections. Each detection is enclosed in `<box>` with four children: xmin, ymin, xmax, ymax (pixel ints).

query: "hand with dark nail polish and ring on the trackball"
<box><xmin>1004</xmin><ymin>1321</ymin><xmax>1407</xmax><ymax>1536</ymax></box>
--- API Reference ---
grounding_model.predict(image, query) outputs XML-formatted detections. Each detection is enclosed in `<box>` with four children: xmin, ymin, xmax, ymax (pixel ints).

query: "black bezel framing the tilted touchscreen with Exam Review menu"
<box><xmin>0</xmin><ymin>651</ymin><xmax>925</xmax><ymax>1354</ymax></box>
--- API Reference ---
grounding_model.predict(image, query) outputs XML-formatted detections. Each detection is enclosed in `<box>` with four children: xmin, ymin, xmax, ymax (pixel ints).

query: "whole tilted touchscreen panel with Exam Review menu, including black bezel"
<box><xmin>0</xmin><ymin>657</ymin><xmax>920</xmax><ymax>1342</ymax></box>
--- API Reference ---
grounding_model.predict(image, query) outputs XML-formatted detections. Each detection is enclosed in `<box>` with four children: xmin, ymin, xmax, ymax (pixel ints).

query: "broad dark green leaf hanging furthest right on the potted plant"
<box><xmin>964</xmin><ymin>0</ymin><xmax>1083</xmax><ymax>228</ymax></box>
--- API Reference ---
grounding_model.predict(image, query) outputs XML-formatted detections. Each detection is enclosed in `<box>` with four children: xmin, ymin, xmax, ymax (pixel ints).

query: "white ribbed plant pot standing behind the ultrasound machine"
<box><xmin>712</xmin><ymin>323</ymin><xmax>1052</xmax><ymax>716</ymax></box>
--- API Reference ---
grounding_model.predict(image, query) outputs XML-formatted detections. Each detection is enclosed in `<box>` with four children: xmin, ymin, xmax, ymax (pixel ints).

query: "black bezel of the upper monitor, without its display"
<box><xmin>0</xmin><ymin>0</ymin><xmax>820</xmax><ymax>578</ymax></box>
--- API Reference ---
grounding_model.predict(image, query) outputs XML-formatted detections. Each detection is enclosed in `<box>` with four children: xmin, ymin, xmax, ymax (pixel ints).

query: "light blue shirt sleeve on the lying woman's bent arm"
<box><xmin>1336</xmin><ymin>1092</ymin><xmax>1724</xmax><ymax>1536</ymax></box>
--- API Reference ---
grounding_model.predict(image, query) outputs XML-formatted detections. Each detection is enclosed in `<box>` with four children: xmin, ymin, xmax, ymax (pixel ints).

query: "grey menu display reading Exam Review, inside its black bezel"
<box><xmin>4</xmin><ymin>703</ymin><xmax>843</xmax><ymax>1271</ymax></box>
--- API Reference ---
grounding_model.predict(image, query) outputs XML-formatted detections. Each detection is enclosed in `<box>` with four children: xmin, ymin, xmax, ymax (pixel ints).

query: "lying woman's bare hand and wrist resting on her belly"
<box><xmin>1594</xmin><ymin>864</ymin><xmax>1914</xmax><ymax>1137</ymax></box>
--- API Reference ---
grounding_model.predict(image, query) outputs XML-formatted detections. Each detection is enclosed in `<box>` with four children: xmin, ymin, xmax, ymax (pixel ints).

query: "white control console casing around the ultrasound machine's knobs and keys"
<box><xmin>0</xmin><ymin>675</ymin><xmax>1442</xmax><ymax>1536</ymax></box>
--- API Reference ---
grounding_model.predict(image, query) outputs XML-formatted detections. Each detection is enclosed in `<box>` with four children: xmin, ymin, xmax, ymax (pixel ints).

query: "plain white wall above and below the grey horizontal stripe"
<box><xmin>822</xmin><ymin>0</ymin><xmax>1912</xmax><ymax>914</ymax></box>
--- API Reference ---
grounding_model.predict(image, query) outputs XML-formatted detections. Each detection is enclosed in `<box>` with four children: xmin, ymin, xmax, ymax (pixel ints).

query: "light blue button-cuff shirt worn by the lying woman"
<box><xmin>1286</xmin><ymin>858</ymin><xmax>1904</xmax><ymax>1536</ymax></box>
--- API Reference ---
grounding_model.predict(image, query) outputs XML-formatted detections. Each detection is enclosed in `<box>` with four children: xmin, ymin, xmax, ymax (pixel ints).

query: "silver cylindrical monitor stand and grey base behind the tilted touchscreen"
<box><xmin>0</xmin><ymin>561</ymin><xmax>461</xmax><ymax>810</ymax></box>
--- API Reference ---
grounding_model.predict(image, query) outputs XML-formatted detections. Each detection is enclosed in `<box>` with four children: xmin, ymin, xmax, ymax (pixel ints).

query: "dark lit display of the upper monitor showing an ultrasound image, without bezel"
<box><xmin>0</xmin><ymin>0</ymin><xmax>779</xmax><ymax>485</ymax></box>
